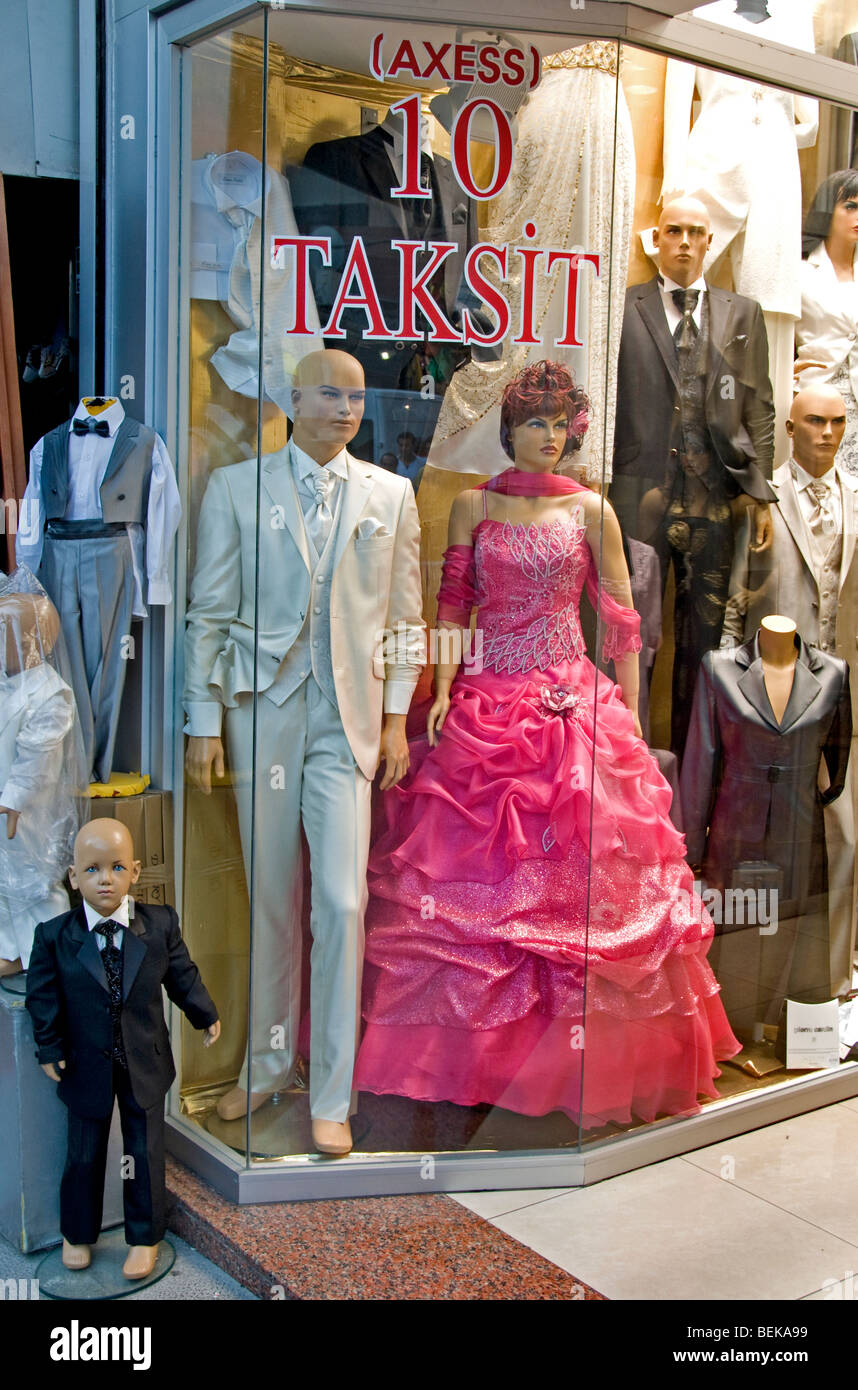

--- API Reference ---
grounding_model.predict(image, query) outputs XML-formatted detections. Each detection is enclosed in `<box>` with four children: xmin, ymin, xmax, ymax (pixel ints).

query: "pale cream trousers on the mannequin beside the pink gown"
<box><xmin>227</xmin><ymin>677</ymin><xmax>371</xmax><ymax>1122</ymax></box>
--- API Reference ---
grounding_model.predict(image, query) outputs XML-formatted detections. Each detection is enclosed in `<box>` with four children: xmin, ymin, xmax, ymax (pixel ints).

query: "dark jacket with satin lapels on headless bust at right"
<box><xmin>680</xmin><ymin>637</ymin><xmax>852</xmax><ymax>915</ymax></box>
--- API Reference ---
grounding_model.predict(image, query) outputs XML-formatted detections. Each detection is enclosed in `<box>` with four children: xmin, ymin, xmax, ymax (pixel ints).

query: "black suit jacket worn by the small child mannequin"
<box><xmin>26</xmin><ymin>904</ymin><xmax>217</xmax><ymax>1119</ymax></box>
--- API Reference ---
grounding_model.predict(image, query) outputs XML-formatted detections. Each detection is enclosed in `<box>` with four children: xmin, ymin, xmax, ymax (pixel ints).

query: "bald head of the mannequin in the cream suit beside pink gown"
<box><xmin>292</xmin><ymin>348</ymin><xmax>366</xmax><ymax>464</ymax></box>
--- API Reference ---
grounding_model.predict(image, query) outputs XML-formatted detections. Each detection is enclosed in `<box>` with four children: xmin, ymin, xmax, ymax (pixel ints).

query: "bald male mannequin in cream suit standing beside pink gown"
<box><xmin>185</xmin><ymin>350</ymin><xmax>424</xmax><ymax>1154</ymax></box>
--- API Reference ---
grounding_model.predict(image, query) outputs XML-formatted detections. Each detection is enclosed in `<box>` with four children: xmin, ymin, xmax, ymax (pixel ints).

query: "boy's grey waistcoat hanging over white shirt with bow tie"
<box><xmin>40</xmin><ymin>416</ymin><xmax>154</xmax><ymax>525</ymax></box>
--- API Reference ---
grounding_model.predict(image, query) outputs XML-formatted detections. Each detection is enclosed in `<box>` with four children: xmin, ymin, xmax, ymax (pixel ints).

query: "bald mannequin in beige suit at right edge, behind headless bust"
<box><xmin>723</xmin><ymin>386</ymin><xmax>858</xmax><ymax>997</ymax></box>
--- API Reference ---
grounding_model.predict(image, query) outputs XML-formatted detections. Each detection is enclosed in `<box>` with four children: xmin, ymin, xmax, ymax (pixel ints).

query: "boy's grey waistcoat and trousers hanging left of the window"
<box><xmin>39</xmin><ymin>416</ymin><xmax>156</xmax><ymax>781</ymax></box>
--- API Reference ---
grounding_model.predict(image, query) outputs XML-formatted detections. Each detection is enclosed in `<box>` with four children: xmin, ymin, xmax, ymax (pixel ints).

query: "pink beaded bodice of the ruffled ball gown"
<box><xmin>474</xmin><ymin>518</ymin><xmax>590</xmax><ymax>674</ymax></box>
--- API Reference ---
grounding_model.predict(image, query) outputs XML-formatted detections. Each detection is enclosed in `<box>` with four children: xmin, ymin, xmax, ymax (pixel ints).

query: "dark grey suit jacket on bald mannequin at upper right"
<box><xmin>610</xmin><ymin>277</ymin><xmax>775</xmax><ymax>541</ymax></box>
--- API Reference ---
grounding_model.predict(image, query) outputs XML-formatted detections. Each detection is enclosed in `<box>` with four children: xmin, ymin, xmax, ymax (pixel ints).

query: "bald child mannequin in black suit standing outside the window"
<box><xmin>26</xmin><ymin>819</ymin><xmax>221</xmax><ymax>1279</ymax></box>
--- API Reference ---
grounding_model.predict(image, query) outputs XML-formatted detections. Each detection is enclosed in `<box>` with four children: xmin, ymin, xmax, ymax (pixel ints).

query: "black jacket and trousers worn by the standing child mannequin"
<box><xmin>26</xmin><ymin>899</ymin><xmax>217</xmax><ymax>1245</ymax></box>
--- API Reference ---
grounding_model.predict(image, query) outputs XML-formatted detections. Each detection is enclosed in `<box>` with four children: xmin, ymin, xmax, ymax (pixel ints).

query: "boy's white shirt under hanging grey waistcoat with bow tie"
<box><xmin>15</xmin><ymin>400</ymin><xmax>182</xmax><ymax>617</ymax></box>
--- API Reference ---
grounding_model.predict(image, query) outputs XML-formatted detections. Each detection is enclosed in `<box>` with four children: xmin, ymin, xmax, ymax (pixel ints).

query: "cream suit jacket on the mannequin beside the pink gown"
<box><xmin>185</xmin><ymin>445</ymin><xmax>426</xmax><ymax>778</ymax></box>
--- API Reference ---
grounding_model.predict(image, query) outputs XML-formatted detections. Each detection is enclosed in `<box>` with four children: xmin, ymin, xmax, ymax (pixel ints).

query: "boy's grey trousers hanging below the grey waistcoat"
<box><xmin>39</xmin><ymin>530</ymin><xmax>133</xmax><ymax>781</ymax></box>
